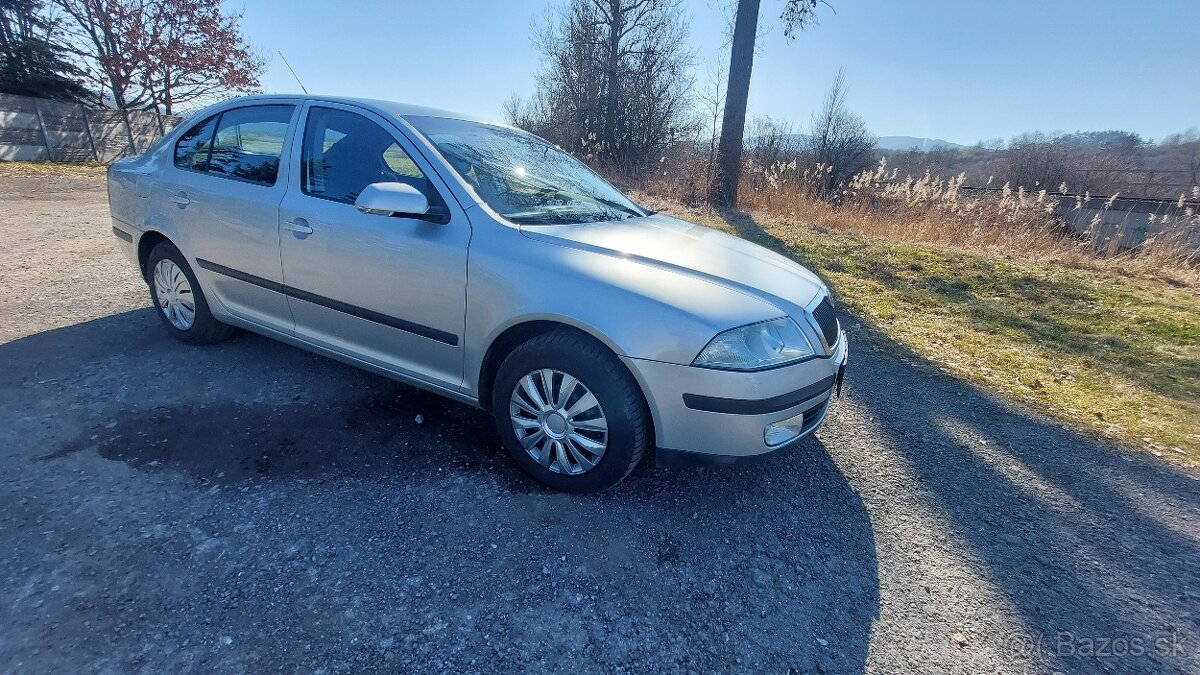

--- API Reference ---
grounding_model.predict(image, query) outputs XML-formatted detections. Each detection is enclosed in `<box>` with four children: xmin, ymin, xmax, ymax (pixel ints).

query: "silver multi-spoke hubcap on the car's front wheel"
<box><xmin>509</xmin><ymin>368</ymin><xmax>608</xmax><ymax>476</ymax></box>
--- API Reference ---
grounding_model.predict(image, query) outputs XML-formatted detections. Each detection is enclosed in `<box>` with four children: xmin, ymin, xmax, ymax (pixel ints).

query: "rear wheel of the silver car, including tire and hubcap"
<box><xmin>145</xmin><ymin>241</ymin><xmax>234</xmax><ymax>345</ymax></box>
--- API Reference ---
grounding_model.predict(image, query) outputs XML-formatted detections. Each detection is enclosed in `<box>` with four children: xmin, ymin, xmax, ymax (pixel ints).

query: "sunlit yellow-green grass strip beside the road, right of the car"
<box><xmin>668</xmin><ymin>209</ymin><xmax>1200</xmax><ymax>466</ymax></box>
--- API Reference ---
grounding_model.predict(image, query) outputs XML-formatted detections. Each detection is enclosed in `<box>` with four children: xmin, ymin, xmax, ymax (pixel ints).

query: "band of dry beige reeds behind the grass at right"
<box><xmin>638</xmin><ymin>161</ymin><xmax>1200</xmax><ymax>288</ymax></box>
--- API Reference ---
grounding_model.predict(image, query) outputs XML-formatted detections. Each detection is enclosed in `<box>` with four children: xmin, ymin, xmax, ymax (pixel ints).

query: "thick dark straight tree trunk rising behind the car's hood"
<box><xmin>712</xmin><ymin>0</ymin><xmax>761</xmax><ymax>207</ymax></box>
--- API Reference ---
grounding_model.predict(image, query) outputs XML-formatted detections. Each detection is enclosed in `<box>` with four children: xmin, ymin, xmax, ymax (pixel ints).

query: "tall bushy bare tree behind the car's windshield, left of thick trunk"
<box><xmin>523</xmin><ymin>0</ymin><xmax>694</xmax><ymax>173</ymax></box>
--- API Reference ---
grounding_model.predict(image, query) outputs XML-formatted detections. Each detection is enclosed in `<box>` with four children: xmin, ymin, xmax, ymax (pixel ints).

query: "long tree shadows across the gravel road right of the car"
<box><xmin>725</xmin><ymin>211</ymin><xmax>1200</xmax><ymax>673</ymax></box>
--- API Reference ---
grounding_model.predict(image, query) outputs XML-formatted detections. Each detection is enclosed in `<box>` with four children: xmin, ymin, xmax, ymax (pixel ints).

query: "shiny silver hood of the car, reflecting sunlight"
<box><xmin>521</xmin><ymin>214</ymin><xmax>826</xmax><ymax>316</ymax></box>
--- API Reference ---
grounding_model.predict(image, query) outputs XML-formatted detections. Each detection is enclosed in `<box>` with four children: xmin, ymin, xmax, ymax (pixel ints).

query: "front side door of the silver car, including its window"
<box><xmin>280</xmin><ymin>103</ymin><xmax>470</xmax><ymax>390</ymax></box>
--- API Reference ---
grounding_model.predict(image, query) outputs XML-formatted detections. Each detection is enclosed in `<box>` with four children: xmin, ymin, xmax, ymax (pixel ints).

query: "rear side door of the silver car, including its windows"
<box><xmin>156</xmin><ymin>103</ymin><xmax>299</xmax><ymax>334</ymax></box>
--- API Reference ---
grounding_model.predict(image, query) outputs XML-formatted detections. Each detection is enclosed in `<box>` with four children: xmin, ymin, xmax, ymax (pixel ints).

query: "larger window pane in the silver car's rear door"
<box><xmin>208</xmin><ymin>106</ymin><xmax>295</xmax><ymax>185</ymax></box>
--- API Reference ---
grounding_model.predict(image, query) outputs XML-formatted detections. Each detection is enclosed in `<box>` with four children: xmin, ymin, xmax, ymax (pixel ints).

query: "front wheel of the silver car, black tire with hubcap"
<box><xmin>492</xmin><ymin>330</ymin><xmax>650</xmax><ymax>492</ymax></box>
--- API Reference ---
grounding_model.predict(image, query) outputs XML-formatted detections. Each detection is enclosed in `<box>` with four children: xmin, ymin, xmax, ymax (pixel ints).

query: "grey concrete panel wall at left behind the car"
<box><xmin>0</xmin><ymin>94</ymin><xmax>179</xmax><ymax>163</ymax></box>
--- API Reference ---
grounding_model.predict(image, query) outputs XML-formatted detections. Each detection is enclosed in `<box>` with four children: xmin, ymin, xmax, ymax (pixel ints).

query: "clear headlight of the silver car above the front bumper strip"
<box><xmin>691</xmin><ymin>316</ymin><xmax>816</xmax><ymax>370</ymax></box>
